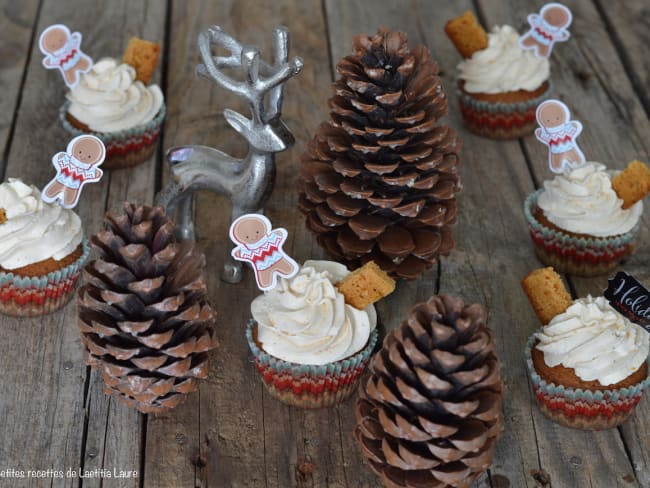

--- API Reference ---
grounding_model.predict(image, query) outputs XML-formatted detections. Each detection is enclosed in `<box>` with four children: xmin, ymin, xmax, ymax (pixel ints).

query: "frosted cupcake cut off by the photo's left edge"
<box><xmin>0</xmin><ymin>178</ymin><xmax>90</xmax><ymax>316</ymax></box>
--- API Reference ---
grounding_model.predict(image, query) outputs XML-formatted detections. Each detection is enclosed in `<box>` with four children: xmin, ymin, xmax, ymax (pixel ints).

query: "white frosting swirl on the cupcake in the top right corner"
<box><xmin>458</xmin><ymin>25</ymin><xmax>551</xmax><ymax>93</ymax></box>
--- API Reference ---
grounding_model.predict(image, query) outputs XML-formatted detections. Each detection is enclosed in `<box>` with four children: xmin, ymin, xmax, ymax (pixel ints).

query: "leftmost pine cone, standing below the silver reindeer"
<box><xmin>77</xmin><ymin>203</ymin><xmax>217</xmax><ymax>413</ymax></box>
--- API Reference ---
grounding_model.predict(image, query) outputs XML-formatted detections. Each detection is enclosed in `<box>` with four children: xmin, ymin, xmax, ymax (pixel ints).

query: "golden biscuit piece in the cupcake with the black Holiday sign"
<box><xmin>521</xmin><ymin>267</ymin><xmax>572</xmax><ymax>325</ymax></box>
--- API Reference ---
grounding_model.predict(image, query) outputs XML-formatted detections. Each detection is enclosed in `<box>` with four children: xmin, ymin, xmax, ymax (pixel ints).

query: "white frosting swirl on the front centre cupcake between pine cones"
<box><xmin>251</xmin><ymin>261</ymin><xmax>377</xmax><ymax>365</ymax></box>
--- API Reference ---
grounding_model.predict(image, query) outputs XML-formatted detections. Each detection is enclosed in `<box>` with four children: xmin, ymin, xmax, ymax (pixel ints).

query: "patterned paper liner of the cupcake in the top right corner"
<box><xmin>457</xmin><ymin>80</ymin><xmax>553</xmax><ymax>139</ymax></box>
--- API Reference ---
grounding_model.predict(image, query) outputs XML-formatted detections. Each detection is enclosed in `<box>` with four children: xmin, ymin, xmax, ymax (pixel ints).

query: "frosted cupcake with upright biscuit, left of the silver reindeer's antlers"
<box><xmin>59</xmin><ymin>39</ymin><xmax>165</xmax><ymax>169</ymax></box>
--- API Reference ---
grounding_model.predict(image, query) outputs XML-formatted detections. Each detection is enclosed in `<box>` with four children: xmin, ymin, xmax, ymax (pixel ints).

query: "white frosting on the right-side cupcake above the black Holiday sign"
<box><xmin>537</xmin><ymin>162</ymin><xmax>643</xmax><ymax>237</ymax></box>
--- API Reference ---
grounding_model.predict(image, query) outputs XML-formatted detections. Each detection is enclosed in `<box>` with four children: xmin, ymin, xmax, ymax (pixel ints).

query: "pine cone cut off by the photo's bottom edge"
<box><xmin>354</xmin><ymin>296</ymin><xmax>503</xmax><ymax>488</ymax></box>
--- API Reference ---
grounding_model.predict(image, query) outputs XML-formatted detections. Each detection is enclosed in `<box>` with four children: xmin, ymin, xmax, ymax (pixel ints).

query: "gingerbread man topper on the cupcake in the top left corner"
<box><xmin>38</xmin><ymin>24</ymin><xmax>93</xmax><ymax>88</ymax></box>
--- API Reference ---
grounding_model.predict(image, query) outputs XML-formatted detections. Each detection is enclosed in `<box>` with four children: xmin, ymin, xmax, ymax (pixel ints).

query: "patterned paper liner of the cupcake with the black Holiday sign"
<box><xmin>525</xmin><ymin>329</ymin><xmax>650</xmax><ymax>430</ymax></box>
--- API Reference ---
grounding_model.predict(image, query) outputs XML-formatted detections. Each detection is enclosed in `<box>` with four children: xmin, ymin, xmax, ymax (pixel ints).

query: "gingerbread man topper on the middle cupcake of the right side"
<box><xmin>535</xmin><ymin>100</ymin><xmax>586</xmax><ymax>173</ymax></box>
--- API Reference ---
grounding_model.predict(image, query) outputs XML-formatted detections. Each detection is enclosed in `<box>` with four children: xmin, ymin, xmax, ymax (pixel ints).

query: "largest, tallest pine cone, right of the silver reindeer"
<box><xmin>298</xmin><ymin>29</ymin><xmax>461</xmax><ymax>278</ymax></box>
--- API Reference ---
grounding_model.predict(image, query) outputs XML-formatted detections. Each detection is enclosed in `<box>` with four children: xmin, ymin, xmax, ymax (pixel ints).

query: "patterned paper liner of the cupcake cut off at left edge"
<box><xmin>0</xmin><ymin>239</ymin><xmax>90</xmax><ymax>317</ymax></box>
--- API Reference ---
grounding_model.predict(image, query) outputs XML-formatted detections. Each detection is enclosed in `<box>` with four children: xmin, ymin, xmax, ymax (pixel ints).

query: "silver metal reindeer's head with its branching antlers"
<box><xmin>196</xmin><ymin>26</ymin><xmax>303</xmax><ymax>152</ymax></box>
